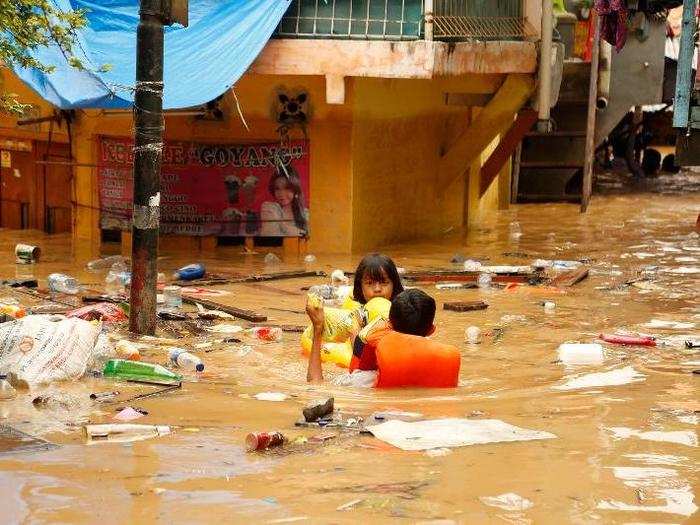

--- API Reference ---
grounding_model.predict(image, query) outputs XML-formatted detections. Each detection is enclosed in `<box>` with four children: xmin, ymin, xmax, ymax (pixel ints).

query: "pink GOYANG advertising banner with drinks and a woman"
<box><xmin>98</xmin><ymin>137</ymin><xmax>309</xmax><ymax>237</ymax></box>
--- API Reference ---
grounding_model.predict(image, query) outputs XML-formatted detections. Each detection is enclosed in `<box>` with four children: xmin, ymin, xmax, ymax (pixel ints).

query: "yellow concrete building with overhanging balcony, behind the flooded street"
<box><xmin>0</xmin><ymin>0</ymin><xmax>542</xmax><ymax>253</ymax></box>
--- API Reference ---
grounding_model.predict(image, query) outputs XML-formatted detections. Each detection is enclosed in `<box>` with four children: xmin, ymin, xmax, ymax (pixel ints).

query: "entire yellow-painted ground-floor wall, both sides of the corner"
<box><xmin>0</xmin><ymin>65</ymin><xmax>524</xmax><ymax>256</ymax></box>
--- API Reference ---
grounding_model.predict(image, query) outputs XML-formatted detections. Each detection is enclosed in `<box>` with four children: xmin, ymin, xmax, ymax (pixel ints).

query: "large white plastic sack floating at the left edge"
<box><xmin>0</xmin><ymin>315</ymin><xmax>101</xmax><ymax>385</ymax></box>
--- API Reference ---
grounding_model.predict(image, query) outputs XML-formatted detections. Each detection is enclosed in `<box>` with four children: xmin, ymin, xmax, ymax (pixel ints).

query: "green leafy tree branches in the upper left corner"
<box><xmin>0</xmin><ymin>0</ymin><xmax>89</xmax><ymax>115</ymax></box>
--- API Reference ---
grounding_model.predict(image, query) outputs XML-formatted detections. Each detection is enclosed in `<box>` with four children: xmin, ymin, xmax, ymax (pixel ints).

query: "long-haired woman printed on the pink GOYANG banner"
<box><xmin>260</xmin><ymin>165</ymin><xmax>309</xmax><ymax>237</ymax></box>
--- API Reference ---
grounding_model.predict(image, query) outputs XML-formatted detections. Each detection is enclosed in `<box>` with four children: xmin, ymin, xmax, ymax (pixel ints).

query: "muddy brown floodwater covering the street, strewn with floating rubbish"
<box><xmin>0</xmin><ymin>177</ymin><xmax>700</xmax><ymax>524</ymax></box>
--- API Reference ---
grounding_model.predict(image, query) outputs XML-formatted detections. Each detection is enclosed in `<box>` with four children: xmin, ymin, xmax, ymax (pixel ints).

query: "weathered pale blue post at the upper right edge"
<box><xmin>673</xmin><ymin>0</ymin><xmax>697</xmax><ymax>128</ymax></box>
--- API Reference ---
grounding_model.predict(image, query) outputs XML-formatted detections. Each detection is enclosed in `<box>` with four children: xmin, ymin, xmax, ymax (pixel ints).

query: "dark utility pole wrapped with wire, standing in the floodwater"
<box><xmin>129</xmin><ymin>0</ymin><xmax>164</xmax><ymax>334</ymax></box>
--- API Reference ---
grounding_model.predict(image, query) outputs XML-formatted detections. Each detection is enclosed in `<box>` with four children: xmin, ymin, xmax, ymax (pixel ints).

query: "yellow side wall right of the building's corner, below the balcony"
<box><xmin>352</xmin><ymin>75</ymin><xmax>503</xmax><ymax>251</ymax></box>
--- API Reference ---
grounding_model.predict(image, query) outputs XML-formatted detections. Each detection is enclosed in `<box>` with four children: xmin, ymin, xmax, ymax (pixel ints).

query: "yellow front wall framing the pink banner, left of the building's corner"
<box><xmin>75</xmin><ymin>75</ymin><xmax>352</xmax><ymax>253</ymax></box>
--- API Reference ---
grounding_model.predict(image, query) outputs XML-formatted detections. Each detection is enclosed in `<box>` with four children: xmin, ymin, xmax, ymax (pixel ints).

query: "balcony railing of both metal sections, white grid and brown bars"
<box><xmin>275</xmin><ymin>0</ymin><xmax>528</xmax><ymax>40</ymax></box>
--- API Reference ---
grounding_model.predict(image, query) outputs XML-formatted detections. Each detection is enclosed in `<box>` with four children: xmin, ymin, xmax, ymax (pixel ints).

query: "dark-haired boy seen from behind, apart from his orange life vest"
<box><xmin>306</xmin><ymin>289</ymin><xmax>435</xmax><ymax>387</ymax></box>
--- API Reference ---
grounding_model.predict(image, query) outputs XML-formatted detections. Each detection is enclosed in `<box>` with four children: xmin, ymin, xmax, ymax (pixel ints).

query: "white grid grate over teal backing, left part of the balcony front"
<box><xmin>275</xmin><ymin>0</ymin><xmax>423</xmax><ymax>40</ymax></box>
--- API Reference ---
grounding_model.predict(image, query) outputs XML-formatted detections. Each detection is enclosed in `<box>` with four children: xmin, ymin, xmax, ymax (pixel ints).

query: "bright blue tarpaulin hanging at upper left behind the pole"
<box><xmin>15</xmin><ymin>0</ymin><xmax>290</xmax><ymax>109</ymax></box>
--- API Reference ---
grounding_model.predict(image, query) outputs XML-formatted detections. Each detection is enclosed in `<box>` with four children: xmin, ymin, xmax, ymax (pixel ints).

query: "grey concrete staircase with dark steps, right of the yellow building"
<box><xmin>517</xmin><ymin>15</ymin><xmax>666</xmax><ymax>202</ymax></box>
